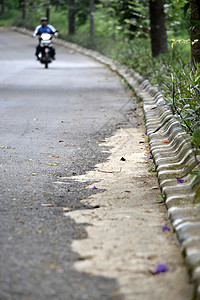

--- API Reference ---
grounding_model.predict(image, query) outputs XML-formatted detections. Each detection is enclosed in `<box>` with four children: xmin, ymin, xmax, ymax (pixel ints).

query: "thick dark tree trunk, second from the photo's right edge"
<box><xmin>149</xmin><ymin>0</ymin><xmax>168</xmax><ymax>57</ymax></box>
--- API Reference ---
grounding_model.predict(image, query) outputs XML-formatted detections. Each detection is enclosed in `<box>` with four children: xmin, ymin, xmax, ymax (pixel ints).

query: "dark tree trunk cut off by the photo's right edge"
<box><xmin>190</xmin><ymin>0</ymin><xmax>200</xmax><ymax>64</ymax></box>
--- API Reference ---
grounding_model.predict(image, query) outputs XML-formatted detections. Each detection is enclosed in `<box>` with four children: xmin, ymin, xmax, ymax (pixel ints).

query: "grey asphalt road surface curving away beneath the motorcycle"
<box><xmin>0</xmin><ymin>28</ymin><xmax>138</xmax><ymax>300</ymax></box>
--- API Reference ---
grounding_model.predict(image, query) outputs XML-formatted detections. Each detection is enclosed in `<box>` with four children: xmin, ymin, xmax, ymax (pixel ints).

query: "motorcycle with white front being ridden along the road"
<box><xmin>39</xmin><ymin>33</ymin><xmax>55</xmax><ymax>69</ymax></box>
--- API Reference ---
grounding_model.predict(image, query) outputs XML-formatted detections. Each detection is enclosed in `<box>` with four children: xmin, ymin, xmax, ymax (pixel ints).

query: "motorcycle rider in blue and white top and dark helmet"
<box><xmin>33</xmin><ymin>17</ymin><xmax>58</xmax><ymax>60</ymax></box>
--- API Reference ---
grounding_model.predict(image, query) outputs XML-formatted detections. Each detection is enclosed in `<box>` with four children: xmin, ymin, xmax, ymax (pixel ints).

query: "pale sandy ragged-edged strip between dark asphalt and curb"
<box><xmin>66</xmin><ymin>128</ymin><xmax>192</xmax><ymax>300</ymax></box>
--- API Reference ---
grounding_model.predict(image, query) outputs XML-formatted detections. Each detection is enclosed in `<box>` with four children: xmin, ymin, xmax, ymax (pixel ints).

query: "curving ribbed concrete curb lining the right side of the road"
<box><xmin>12</xmin><ymin>27</ymin><xmax>200</xmax><ymax>300</ymax></box>
